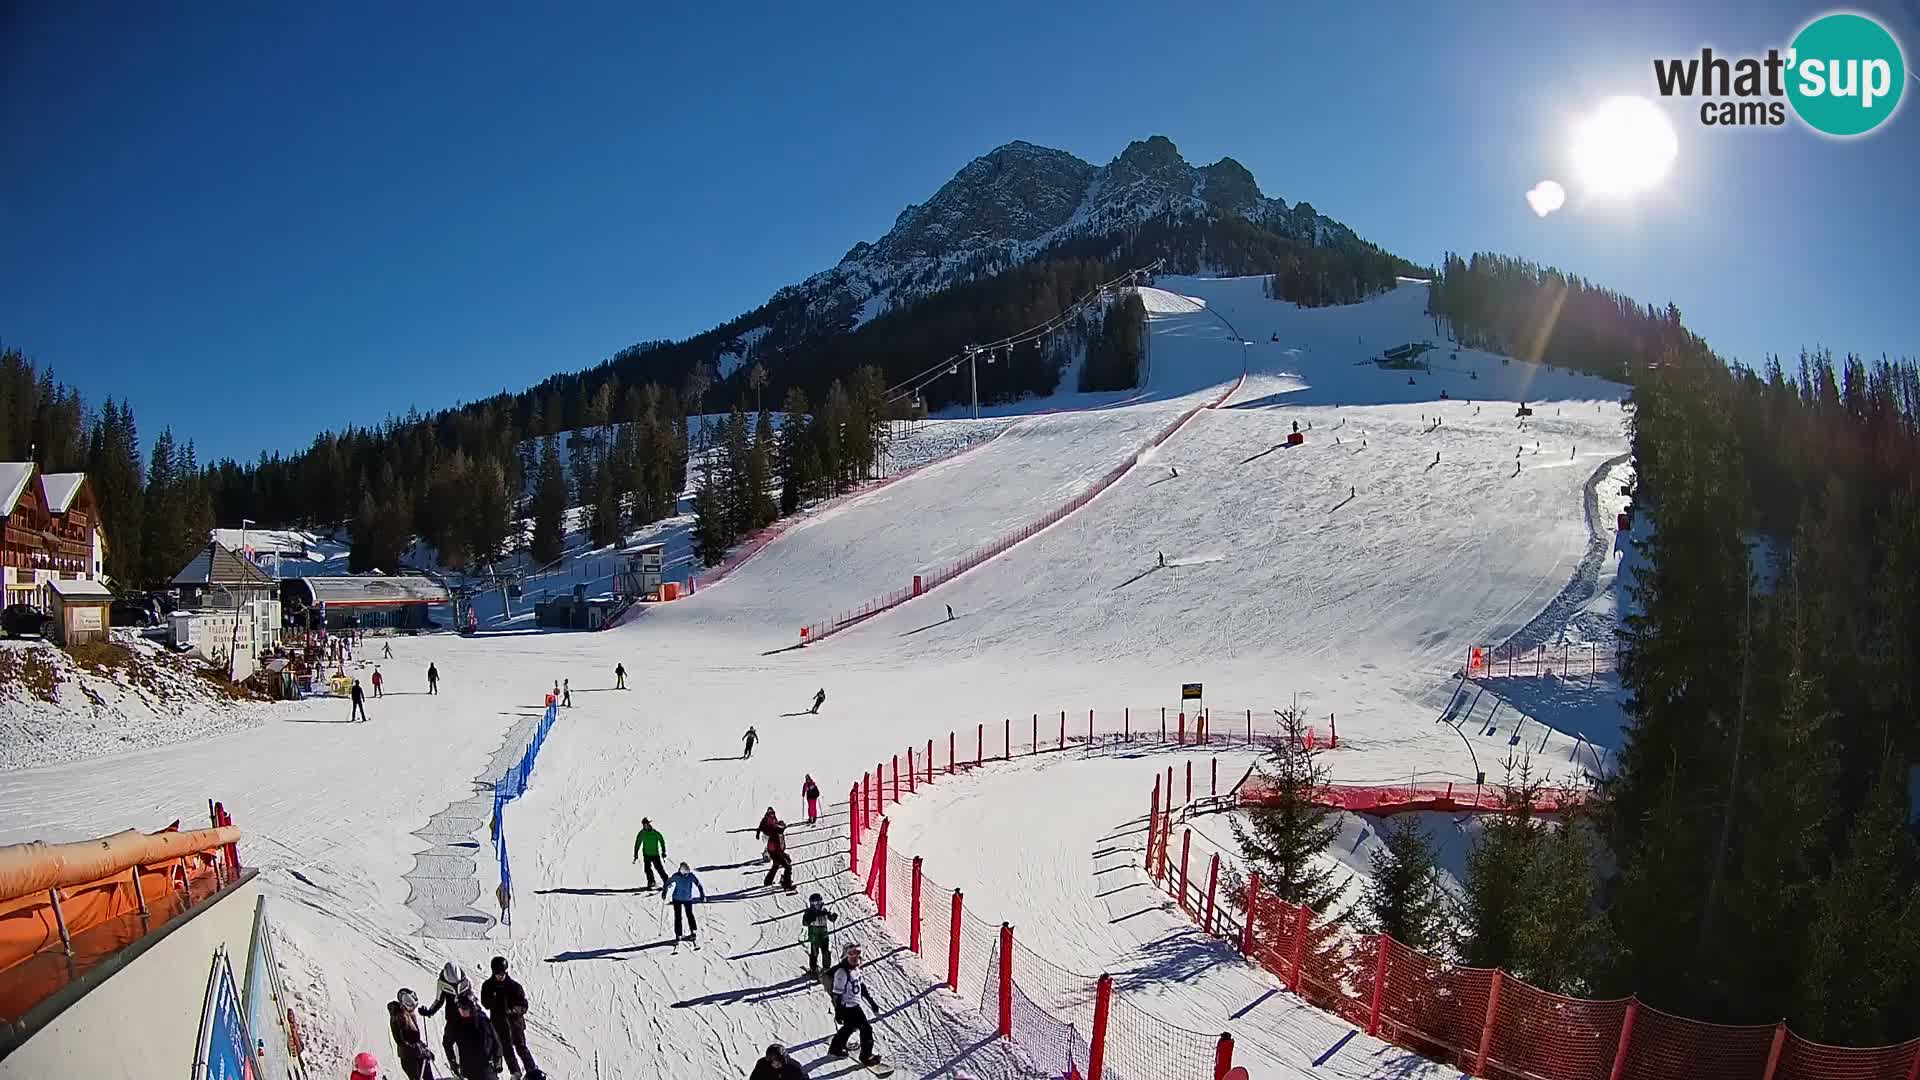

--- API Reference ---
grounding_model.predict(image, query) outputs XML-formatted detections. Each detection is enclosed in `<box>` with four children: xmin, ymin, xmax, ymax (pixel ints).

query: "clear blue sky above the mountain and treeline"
<box><xmin>0</xmin><ymin>0</ymin><xmax>1920</xmax><ymax>459</ymax></box>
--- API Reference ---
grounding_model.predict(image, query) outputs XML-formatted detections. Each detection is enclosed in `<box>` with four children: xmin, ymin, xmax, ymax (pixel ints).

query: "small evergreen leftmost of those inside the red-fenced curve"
<box><xmin>1233</xmin><ymin>707</ymin><xmax>1342</xmax><ymax>915</ymax></box>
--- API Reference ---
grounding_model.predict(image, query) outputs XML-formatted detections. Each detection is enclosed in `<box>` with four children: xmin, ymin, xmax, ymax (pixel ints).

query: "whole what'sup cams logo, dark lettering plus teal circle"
<box><xmin>1653</xmin><ymin>12</ymin><xmax>1907</xmax><ymax>138</ymax></box>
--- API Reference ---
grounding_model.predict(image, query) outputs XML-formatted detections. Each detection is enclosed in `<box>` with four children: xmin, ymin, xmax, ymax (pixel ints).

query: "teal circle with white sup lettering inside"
<box><xmin>1788</xmin><ymin>12</ymin><xmax>1907</xmax><ymax>136</ymax></box>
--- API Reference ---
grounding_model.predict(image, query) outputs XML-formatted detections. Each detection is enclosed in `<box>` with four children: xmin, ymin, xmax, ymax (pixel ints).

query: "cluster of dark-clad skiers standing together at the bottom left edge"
<box><xmin>353</xmin><ymin>957</ymin><xmax>545</xmax><ymax>1080</ymax></box>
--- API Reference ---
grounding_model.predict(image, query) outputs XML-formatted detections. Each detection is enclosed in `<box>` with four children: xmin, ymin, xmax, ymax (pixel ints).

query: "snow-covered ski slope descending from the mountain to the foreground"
<box><xmin>0</xmin><ymin>279</ymin><xmax>1626</xmax><ymax>1080</ymax></box>
